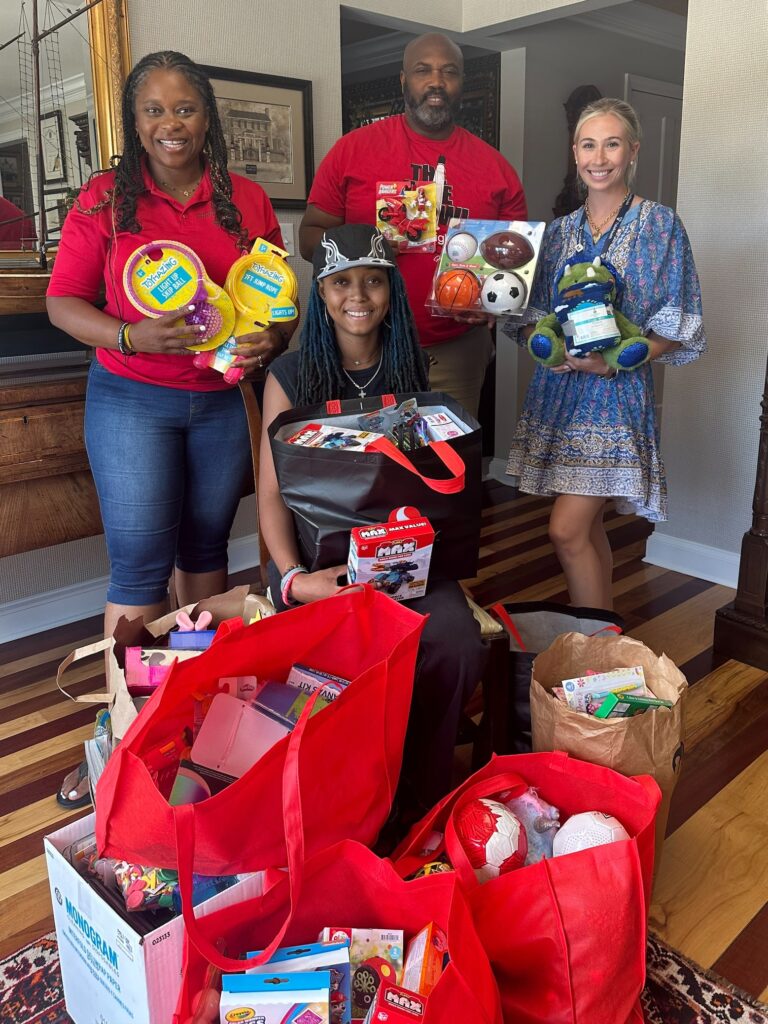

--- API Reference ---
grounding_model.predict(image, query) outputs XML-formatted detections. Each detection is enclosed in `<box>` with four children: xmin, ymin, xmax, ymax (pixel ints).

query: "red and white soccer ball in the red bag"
<box><xmin>455</xmin><ymin>800</ymin><xmax>528</xmax><ymax>882</ymax></box>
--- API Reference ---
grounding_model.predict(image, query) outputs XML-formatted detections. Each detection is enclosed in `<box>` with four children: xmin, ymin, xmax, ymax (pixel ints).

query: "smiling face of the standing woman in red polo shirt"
<box><xmin>134</xmin><ymin>69</ymin><xmax>208</xmax><ymax>184</ymax></box>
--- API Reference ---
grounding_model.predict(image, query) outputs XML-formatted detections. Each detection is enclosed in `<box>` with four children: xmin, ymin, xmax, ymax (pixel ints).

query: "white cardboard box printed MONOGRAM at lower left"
<box><xmin>45</xmin><ymin>814</ymin><xmax>263</xmax><ymax>1024</ymax></box>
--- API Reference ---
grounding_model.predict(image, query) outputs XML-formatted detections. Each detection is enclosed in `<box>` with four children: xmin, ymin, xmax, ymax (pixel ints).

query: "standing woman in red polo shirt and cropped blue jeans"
<box><xmin>47</xmin><ymin>51</ymin><xmax>293</xmax><ymax>798</ymax></box>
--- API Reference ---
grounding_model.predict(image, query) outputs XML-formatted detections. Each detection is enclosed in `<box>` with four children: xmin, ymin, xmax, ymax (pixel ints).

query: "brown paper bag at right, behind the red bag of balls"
<box><xmin>530</xmin><ymin>633</ymin><xmax>688</xmax><ymax>867</ymax></box>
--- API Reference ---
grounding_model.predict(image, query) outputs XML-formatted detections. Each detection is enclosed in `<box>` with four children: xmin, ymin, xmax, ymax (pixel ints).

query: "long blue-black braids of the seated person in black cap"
<box><xmin>296</xmin><ymin>267</ymin><xmax>429</xmax><ymax>406</ymax></box>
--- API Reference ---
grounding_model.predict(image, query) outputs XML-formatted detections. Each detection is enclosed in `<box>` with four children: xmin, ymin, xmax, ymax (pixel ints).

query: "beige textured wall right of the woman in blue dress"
<box><xmin>650</xmin><ymin>0</ymin><xmax>768</xmax><ymax>569</ymax></box>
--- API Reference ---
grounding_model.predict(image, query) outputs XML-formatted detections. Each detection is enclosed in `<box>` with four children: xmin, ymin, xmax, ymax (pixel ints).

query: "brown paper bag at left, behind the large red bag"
<box><xmin>56</xmin><ymin>586</ymin><xmax>274</xmax><ymax>742</ymax></box>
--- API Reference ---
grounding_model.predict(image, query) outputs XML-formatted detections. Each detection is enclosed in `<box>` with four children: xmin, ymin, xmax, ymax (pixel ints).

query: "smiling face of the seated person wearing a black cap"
<box><xmin>317</xmin><ymin>266</ymin><xmax>389</xmax><ymax>355</ymax></box>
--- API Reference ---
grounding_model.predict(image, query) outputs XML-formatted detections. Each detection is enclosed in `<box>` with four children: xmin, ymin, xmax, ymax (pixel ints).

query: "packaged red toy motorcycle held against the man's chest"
<box><xmin>376</xmin><ymin>181</ymin><xmax>437</xmax><ymax>253</ymax></box>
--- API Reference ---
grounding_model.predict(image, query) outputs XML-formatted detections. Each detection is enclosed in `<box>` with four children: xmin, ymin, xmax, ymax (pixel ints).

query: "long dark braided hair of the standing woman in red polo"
<box><xmin>78</xmin><ymin>50</ymin><xmax>248</xmax><ymax>250</ymax></box>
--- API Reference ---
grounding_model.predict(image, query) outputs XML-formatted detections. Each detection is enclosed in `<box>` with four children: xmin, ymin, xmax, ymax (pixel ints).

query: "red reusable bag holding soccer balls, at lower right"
<box><xmin>393</xmin><ymin>752</ymin><xmax>660</xmax><ymax>1024</ymax></box>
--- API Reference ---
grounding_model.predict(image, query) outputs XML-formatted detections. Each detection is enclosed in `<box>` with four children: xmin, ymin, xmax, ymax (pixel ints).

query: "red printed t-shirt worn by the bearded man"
<box><xmin>308</xmin><ymin>114</ymin><xmax>527</xmax><ymax>345</ymax></box>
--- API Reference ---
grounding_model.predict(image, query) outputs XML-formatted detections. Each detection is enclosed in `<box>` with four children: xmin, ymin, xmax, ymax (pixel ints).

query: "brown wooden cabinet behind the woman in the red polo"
<box><xmin>0</xmin><ymin>369</ymin><xmax>102</xmax><ymax>557</ymax></box>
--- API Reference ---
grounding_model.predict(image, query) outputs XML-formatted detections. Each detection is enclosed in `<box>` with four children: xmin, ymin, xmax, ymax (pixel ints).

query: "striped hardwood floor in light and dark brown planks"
<box><xmin>0</xmin><ymin>481</ymin><xmax>768</xmax><ymax>1000</ymax></box>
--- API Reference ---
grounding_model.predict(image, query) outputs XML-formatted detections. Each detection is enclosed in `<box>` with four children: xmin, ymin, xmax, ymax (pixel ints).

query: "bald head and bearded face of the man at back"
<box><xmin>400</xmin><ymin>35</ymin><xmax>464</xmax><ymax>137</ymax></box>
